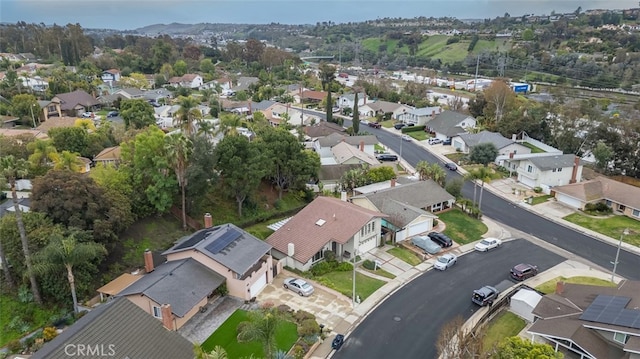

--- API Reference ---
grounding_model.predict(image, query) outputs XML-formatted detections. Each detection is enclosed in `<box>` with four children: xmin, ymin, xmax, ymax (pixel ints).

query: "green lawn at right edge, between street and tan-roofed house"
<box><xmin>563</xmin><ymin>213</ymin><xmax>640</xmax><ymax>247</ymax></box>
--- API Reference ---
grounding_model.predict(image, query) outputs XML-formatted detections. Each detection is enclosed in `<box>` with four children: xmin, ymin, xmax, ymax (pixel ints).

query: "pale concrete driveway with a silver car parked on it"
<box><xmin>256</xmin><ymin>270</ymin><xmax>352</xmax><ymax>328</ymax></box>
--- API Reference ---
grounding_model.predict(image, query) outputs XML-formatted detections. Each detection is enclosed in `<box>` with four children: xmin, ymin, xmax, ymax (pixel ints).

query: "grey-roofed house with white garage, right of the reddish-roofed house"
<box><xmin>350</xmin><ymin>180</ymin><xmax>455</xmax><ymax>242</ymax></box>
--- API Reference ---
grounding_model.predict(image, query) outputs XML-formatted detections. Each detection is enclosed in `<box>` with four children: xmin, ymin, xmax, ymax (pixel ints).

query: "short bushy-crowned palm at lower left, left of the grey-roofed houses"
<box><xmin>35</xmin><ymin>232</ymin><xmax>107</xmax><ymax>313</ymax></box>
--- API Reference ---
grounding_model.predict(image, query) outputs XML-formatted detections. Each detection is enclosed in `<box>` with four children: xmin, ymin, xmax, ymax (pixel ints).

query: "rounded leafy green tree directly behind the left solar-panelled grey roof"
<box><xmin>216</xmin><ymin>135</ymin><xmax>267</xmax><ymax>216</ymax></box>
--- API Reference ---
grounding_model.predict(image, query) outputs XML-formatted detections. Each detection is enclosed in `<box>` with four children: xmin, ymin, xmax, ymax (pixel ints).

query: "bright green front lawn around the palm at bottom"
<box><xmin>202</xmin><ymin>310</ymin><xmax>298</xmax><ymax>359</ymax></box>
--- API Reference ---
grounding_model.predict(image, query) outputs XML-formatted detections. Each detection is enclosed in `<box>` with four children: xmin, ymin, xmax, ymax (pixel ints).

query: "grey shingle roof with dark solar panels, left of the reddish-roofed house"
<box><xmin>163</xmin><ymin>223</ymin><xmax>271</xmax><ymax>275</ymax></box>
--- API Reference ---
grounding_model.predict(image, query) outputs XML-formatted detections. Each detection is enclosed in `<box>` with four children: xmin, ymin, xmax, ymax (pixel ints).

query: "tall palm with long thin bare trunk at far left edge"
<box><xmin>0</xmin><ymin>155</ymin><xmax>42</xmax><ymax>304</ymax></box>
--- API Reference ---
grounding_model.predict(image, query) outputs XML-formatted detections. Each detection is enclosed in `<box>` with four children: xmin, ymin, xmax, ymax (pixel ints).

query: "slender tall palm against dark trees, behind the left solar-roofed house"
<box><xmin>165</xmin><ymin>133</ymin><xmax>193</xmax><ymax>231</ymax></box>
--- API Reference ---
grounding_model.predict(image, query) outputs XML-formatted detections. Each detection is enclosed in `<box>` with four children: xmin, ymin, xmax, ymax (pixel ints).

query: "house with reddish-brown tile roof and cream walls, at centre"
<box><xmin>267</xmin><ymin>197</ymin><xmax>386</xmax><ymax>271</ymax></box>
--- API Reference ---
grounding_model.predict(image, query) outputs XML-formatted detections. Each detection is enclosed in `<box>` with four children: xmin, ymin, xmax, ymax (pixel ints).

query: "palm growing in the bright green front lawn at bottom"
<box><xmin>238</xmin><ymin>308</ymin><xmax>285</xmax><ymax>358</ymax></box>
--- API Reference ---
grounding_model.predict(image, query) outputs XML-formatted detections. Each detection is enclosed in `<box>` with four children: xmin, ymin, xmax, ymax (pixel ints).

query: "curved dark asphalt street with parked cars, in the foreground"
<box><xmin>333</xmin><ymin>239</ymin><xmax>565</xmax><ymax>359</ymax></box>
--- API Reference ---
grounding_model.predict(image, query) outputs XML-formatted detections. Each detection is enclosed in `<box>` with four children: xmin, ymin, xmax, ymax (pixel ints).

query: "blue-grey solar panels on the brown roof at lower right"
<box><xmin>580</xmin><ymin>295</ymin><xmax>640</xmax><ymax>329</ymax></box>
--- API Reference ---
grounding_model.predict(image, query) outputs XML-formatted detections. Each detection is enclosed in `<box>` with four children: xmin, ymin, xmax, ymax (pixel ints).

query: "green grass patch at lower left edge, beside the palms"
<box><xmin>0</xmin><ymin>294</ymin><xmax>60</xmax><ymax>347</ymax></box>
